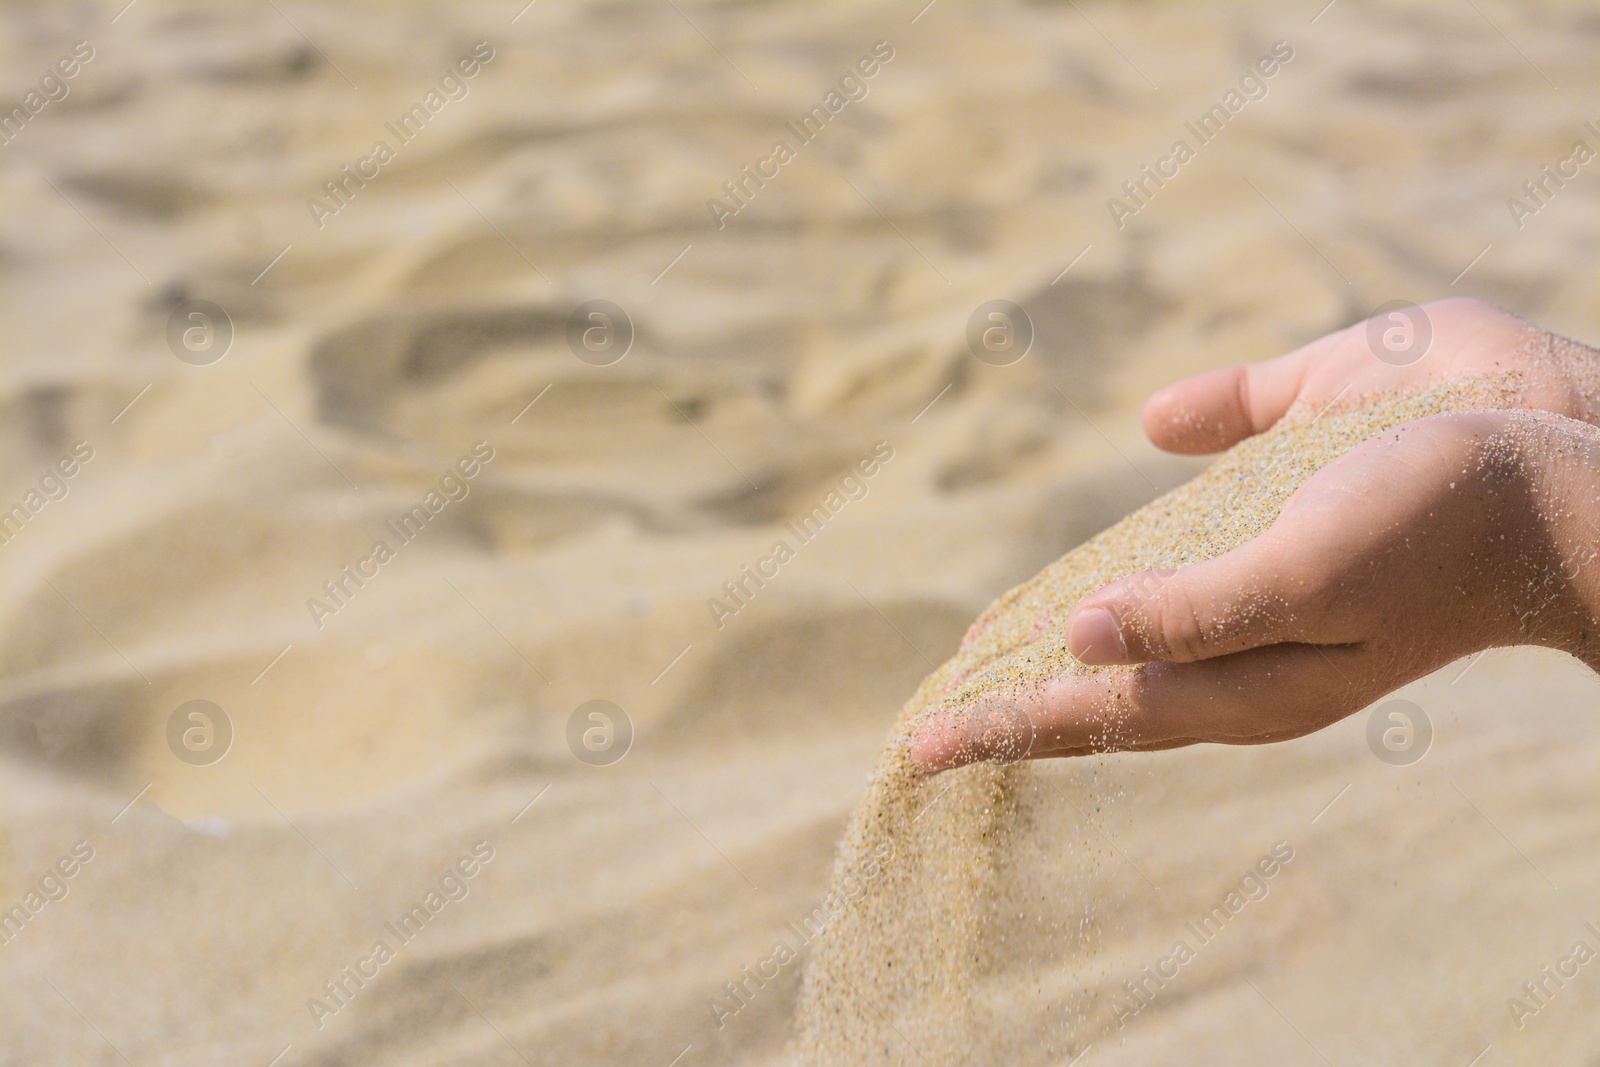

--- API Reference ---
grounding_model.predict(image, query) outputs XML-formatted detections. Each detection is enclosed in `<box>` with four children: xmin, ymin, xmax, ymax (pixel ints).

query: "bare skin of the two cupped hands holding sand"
<box><xmin>912</xmin><ymin>301</ymin><xmax>1600</xmax><ymax>773</ymax></box>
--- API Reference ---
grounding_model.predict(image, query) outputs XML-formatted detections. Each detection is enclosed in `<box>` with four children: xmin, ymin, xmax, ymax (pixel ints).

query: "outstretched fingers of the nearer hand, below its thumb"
<box><xmin>912</xmin><ymin>645</ymin><xmax>1376</xmax><ymax>774</ymax></box>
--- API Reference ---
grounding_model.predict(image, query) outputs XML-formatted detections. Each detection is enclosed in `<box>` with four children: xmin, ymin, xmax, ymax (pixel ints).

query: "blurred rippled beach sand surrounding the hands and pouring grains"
<box><xmin>9</xmin><ymin>0</ymin><xmax>1600</xmax><ymax>1067</ymax></box>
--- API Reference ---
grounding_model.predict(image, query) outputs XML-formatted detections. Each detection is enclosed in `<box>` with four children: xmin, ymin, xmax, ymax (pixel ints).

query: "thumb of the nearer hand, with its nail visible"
<box><xmin>1066</xmin><ymin>534</ymin><xmax>1317</xmax><ymax>665</ymax></box>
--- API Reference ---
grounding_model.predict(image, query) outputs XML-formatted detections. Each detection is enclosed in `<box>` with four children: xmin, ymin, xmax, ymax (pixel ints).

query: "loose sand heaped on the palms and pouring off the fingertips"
<box><xmin>794</xmin><ymin>374</ymin><xmax>1517</xmax><ymax>1067</ymax></box>
